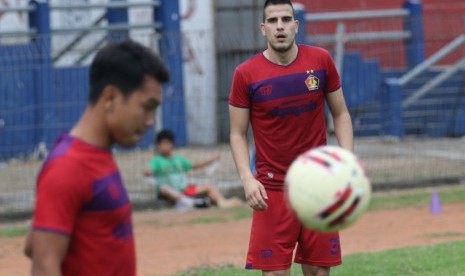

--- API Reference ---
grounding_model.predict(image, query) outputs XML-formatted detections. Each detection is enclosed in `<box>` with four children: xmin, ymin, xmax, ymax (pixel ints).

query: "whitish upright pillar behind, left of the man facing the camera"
<box><xmin>179</xmin><ymin>0</ymin><xmax>217</xmax><ymax>145</ymax></box>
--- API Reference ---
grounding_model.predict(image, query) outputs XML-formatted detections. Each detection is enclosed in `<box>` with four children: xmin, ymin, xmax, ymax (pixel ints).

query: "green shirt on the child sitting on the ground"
<box><xmin>149</xmin><ymin>155</ymin><xmax>192</xmax><ymax>192</ymax></box>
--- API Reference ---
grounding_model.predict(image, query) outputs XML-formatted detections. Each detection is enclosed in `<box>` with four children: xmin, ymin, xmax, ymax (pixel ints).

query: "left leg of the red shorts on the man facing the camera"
<box><xmin>246</xmin><ymin>190</ymin><xmax>300</xmax><ymax>271</ymax></box>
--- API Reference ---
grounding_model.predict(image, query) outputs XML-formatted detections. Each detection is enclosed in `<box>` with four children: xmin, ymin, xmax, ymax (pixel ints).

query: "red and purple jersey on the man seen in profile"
<box><xmin>33</xmin><ymin>134</ymin><xmax>136</xmax><ymax>275</ymax></box>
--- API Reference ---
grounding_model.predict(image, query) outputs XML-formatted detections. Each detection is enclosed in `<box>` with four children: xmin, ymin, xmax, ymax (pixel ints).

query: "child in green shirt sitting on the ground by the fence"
<box><xmin>144</xmin><ymin>130</ymin><xmax>242</xmax><ymax>210</ymax></box>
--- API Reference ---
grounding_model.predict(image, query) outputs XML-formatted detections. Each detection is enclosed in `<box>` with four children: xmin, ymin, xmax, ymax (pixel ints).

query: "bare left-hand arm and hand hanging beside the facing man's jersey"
<box><xmin>229</xmin><ymin>105</ymin><xmax>268</xmax><ymax>211</ymax></box>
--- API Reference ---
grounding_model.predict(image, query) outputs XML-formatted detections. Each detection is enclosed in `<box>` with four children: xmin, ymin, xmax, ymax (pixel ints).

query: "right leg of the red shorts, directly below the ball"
<box><xmin>295</xmin><ymin>228</ymin><xmax>342</xmax><ymax>267</ymax></box>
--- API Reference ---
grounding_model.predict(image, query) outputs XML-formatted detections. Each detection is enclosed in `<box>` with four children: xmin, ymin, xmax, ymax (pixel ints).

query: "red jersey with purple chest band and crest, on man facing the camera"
<box><xmin>229</xmin><ymin>45</ymin><xmax>341</xmax><ymax>189</ymax></box>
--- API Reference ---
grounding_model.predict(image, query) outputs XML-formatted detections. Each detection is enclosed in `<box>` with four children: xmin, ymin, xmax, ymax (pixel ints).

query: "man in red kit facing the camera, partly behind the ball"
<box><xmin>229</xmin><ymin>0</ymin><xmax>353</xmax><ymax>276</ymax></box>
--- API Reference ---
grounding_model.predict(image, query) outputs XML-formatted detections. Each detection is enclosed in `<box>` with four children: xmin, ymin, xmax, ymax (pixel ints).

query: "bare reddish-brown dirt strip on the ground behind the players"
<box><xmin>0</xmin><ymin>203</ymin><xmax>465</xmax><ymax>276</ymax></box>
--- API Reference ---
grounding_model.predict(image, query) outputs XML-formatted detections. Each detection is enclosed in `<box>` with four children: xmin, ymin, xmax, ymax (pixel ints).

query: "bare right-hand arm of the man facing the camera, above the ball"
<box><xmin>326</xmin><ymin>88</ymin><xmax>354</xmax><ymax>151</ymax></box>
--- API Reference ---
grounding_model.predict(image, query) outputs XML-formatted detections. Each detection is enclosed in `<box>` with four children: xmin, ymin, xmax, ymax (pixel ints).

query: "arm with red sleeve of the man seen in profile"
<box><xmin>26</xmin><ymin>158</ymin><xmax>85</xmax><ymax>275</ymax></box>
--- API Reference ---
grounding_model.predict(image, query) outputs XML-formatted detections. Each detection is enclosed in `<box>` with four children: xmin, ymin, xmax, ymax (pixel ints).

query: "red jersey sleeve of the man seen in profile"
<box><xmin>33</xmin><ymin>158</ymin><xmax>92</xmax><ymax>235</ymax></box>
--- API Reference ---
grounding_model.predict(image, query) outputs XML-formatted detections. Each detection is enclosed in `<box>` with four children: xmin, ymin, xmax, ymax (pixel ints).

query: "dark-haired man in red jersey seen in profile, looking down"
<box><xmin>25</xmin><ymin>40</ymin><xmax>169</xmax><ymax>276</ymax></box>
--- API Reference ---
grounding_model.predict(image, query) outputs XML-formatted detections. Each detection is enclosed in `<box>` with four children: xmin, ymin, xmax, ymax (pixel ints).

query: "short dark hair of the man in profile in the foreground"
<box><xmin>88</xmin><ymin>39</ymin><xmax>170</xmax><ymax>104</ymax></box>
